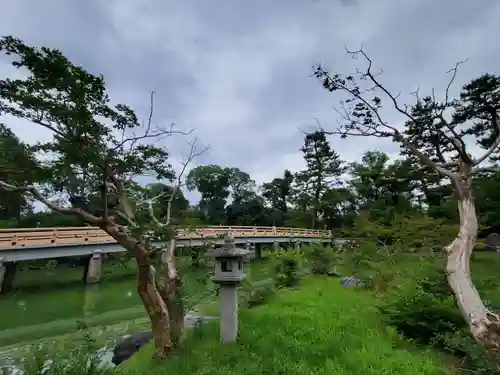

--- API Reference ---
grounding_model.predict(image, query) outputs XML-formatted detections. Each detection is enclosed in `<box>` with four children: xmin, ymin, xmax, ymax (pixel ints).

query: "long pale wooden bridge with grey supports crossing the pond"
<box><xmin>0</xmin><ymin>226</ymin><xmax>332</xmax><ymax>293</ymax></box>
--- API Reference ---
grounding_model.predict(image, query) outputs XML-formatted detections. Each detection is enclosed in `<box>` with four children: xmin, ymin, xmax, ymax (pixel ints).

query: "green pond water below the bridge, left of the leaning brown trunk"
<box><xmin>0</xmin><ymin>270</ymin><xmax>148</xmax><ymax>366</ymax></box>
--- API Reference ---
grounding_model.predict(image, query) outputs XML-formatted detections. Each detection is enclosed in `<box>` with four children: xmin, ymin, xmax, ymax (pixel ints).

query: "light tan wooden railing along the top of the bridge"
<box><xmin>0</xmin><ymin>226</ymin><xmax>330</xmax><ymax>251</ymax></box>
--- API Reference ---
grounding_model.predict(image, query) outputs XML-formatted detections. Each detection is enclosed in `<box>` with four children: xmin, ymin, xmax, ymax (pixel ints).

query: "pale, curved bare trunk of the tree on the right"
<box><xmin>445</xmin><ymin>164</ymin><xmax>500</xmax><ymax>363</ymax></box>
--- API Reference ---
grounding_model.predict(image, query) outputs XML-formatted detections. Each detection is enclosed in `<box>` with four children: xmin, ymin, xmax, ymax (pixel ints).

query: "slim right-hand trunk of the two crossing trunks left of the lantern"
<box><xmin>157</xmin><ymin>239</ymin><xmax>185</xmax><ymax>347</ymax></box>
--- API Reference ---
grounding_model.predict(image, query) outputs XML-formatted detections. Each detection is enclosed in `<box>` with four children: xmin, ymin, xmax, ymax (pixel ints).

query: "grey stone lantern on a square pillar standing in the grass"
<box><xmin>210</xmin><ymin>235</ymin><xmax>250</xmax><ymax>342</ymax></box>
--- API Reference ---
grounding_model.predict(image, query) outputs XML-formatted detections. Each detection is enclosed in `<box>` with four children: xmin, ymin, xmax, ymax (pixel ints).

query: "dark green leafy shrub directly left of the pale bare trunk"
<box><xmin>378</xmin><ymin>260</ymin><xmax>500</xmax><ymax>375</ymax></box>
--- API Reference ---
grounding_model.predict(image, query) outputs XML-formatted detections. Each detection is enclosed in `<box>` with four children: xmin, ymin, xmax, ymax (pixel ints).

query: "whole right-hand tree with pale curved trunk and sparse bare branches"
<box><xmin>314</xmin><ymin>50</ymin><xmax>500</xmax><ymax>362</ymax></box>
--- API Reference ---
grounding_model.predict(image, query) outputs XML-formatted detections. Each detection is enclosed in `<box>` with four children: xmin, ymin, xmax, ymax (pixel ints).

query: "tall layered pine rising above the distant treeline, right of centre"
<box><xmin>299</xmin><ymin>130</ymin><xmax>345</xmax><ymax>228</ymax></box>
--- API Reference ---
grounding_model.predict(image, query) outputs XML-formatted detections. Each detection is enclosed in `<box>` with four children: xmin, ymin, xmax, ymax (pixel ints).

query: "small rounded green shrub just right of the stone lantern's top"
<box><xmin>271</xmin><ymin>250</ymin><xmax>304</xmax><ymax>287</ymax></box>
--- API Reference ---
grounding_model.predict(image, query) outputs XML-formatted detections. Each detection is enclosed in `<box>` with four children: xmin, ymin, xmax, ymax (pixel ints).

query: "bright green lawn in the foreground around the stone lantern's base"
<box><xmin>117</xmin><ymin>278</ymin><xmax>450</xmax><ymax>375</ymax></box>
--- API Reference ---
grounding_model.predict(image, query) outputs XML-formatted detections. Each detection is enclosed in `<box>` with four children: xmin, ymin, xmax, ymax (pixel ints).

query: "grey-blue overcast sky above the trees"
<box><xmin>0</xmin><ymin>0</ymin><xmax>500</xmax><ymax>204</ymax></box>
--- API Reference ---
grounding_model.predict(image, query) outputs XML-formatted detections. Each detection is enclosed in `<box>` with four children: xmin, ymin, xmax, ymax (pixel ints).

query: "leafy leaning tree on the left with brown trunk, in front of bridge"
<box><xmin>0</xmin><ymin>36</ymin><xmax>198</xmax><ymax>358</ymax></box>
